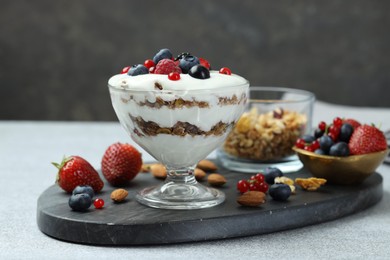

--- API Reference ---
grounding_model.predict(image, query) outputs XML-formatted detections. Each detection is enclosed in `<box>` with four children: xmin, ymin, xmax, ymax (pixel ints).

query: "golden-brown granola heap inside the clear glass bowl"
<box><xmin>223</xmin><ymin>107</ymin><xmax>307</xmax><ymax>161</ymax></box>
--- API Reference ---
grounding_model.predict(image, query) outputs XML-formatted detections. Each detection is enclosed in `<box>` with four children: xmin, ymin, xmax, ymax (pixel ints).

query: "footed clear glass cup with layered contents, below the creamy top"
<box><xmin>109</xmin><ymin>82</ymin><xmax>249</xmax><ymax>209</ymax></box>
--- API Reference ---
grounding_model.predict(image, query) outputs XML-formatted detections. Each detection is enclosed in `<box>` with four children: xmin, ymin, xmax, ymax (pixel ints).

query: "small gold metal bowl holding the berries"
<box><xmin>293</xmin><ymin>147</ymin><xmax>389</xmax><ymax>185</ymax></box>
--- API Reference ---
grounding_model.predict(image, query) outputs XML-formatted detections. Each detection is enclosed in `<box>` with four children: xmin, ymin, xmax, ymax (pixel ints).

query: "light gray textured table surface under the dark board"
<box><xmin>0</xmin><ymin>102</ymin><xmax>390</xmax><ymax>259</ymax></box>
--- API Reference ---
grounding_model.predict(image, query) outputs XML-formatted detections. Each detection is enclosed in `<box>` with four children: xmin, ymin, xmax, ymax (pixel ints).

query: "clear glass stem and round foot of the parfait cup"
<box><xmin>136</xmin><ymin>167</ymin><xmax>225</xmax><ymax>209</ymax></box>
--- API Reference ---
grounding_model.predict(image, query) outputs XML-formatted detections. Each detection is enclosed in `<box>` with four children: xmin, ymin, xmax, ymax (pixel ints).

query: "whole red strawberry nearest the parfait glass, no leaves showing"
<box><xmin>102</xmin><ymin>143</ymin><xmax>142</xmax><ymax>186</ymax></box>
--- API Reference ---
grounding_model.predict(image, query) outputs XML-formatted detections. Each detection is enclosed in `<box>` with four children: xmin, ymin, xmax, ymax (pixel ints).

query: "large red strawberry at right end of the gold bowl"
<box><xmin>348</xmin><ymin>125</ymin><xmax>387</xmax><ymax>154</ymax></box>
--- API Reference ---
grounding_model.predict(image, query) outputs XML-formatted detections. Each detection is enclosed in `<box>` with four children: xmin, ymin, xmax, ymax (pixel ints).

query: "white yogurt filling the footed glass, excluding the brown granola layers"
<box><xmin>109</xmin><ymin>69</ymin><xmax>249</xmax><ymax>167</ymax></box>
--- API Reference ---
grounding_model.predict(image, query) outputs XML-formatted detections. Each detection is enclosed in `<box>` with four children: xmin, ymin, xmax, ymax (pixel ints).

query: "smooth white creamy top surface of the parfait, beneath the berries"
<box><xmin>108</xmin><ymin>71</ymin><xmax>248</xmax><ymax>90</ymax></box>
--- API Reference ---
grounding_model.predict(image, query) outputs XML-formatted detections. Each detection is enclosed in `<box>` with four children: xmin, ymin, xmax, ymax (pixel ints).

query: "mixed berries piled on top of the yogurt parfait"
<box><xmin>121</xmin><ymin>49</ymin><xmax>232</xmax><ymax>81</ymax></box>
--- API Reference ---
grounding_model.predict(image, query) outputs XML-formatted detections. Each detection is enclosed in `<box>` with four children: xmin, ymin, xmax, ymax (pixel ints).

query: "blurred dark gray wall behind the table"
<box><xmin>0</xmin><ymin>0</ymin><xmax>390</xmax><ymax>120</ymax></box>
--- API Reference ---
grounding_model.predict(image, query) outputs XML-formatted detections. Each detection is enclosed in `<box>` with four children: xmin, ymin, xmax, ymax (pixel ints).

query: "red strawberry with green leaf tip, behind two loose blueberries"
<box><xmin>52</xmin><ymin>156</ymin><xmax>104</xmax><ymax>193</ymax></box>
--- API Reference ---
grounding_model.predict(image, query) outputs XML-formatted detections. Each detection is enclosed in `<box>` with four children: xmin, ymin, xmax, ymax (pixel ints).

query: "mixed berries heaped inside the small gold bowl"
<box><xmin>295</xmin><ymin>117</ymin><xmax>387</xmax><ymax>157</ymax></box>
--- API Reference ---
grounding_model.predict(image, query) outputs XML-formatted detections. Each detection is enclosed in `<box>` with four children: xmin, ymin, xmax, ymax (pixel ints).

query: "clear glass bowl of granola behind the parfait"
<box><xmin>217</xmin><ymin>87</ymin><xmax>315</xmax><ymax>173</ymax></box>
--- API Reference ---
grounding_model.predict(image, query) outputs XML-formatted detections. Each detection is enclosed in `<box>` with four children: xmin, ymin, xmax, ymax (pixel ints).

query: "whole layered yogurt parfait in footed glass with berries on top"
<box><xmin>108</xmin><ymin>49</ymin><xmax>249</xmax><ymax>209</ymax></box>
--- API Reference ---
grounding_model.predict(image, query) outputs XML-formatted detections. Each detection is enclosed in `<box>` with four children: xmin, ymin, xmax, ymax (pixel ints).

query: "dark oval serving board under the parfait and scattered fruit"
<box><xmin>37</xmin><ymin>167</ymin><xmax>383</xmax><ymax>246</ymax></box>
